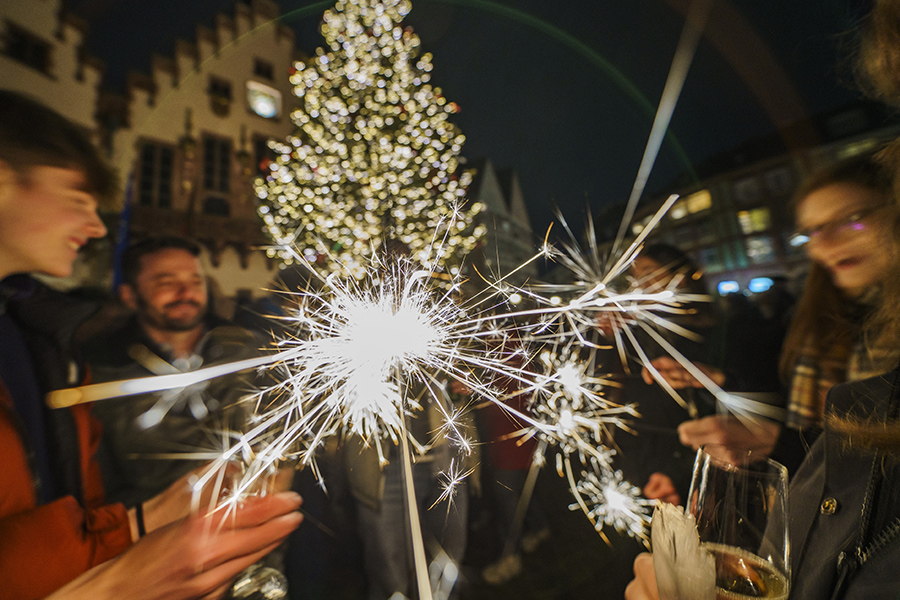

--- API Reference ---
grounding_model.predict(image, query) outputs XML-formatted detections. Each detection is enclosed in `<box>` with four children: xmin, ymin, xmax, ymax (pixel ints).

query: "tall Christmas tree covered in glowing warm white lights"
<box><xmin>256</xmin><ymin>0</ymin><xmax>484</xmax><ymax>276</ymax></box>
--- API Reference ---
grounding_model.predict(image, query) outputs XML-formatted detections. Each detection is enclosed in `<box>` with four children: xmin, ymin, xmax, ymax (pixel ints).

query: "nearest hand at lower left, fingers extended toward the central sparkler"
<box><xmin>47</xmin><ymin>492</ymin><xmax>302</xmax><ymax>600</ymax></box>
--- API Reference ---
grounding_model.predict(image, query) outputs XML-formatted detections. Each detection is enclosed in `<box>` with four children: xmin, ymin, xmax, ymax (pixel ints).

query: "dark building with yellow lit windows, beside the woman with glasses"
<box><xmin>631</xmin><ymin>108</ymin><xmax>900</xmax><ymax>293</ymax></box>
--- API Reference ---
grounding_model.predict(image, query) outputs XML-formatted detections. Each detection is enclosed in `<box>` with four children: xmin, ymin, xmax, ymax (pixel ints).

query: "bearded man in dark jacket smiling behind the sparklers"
<box><xmin>85</xmin><ymin>237</ymin><xmax>259</xmax><ymax>506</ymax></box>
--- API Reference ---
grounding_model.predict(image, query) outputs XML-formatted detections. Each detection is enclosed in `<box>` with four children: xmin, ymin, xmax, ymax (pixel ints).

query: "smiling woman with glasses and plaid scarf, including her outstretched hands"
<box><xmin>645</xmin><ymin>155</ymin><xmax>897</xmax><ymax>474</ymax></box>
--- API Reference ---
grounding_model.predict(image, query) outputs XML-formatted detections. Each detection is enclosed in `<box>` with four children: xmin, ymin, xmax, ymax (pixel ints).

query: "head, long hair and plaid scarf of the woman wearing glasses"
<box><xmin>780</xmin><ymin>157</ymin><xmax>896</xmax><ymax>429</ymax></box>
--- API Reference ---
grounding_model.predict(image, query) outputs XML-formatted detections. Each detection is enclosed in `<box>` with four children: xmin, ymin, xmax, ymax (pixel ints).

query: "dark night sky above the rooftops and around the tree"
<box><xmin>68</xmin><ymin>0</ymin><xmax>867</xmax><ymax>238</ymax></box>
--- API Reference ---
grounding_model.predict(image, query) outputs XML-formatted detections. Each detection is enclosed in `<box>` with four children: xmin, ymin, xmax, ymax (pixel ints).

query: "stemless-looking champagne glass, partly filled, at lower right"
<box><xmin>685</xmin><ymin>446</ymin><xmax>790</xmax><ymax>600</ymax></box>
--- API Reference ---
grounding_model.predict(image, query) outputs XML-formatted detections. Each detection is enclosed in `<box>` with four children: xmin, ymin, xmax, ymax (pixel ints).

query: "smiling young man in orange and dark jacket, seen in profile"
<box><xmin>0</xmin><ymin>91</ymin><xmax>300</xmax><ymax>600</ymax></box>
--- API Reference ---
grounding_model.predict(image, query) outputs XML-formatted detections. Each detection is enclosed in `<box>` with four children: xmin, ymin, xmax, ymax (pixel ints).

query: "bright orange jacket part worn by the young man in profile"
<box><xmin>0</xmin><ymin>383</ymin><xmax>131</xmax><ymax>600</ymax></box>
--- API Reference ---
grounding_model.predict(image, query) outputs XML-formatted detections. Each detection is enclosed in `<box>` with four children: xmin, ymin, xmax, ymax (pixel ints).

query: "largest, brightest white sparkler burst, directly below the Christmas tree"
<box><xmin>219</xmin><ymin>244</ymin><xmax>544</xmax><ymax>497</ymax></box>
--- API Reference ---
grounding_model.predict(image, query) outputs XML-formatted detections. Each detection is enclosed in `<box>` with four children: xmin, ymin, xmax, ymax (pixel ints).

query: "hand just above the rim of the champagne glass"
<box><xmin>678</xmin><ymin>415</ymin><xmax>781</xmax><ymax>463</ymax></box>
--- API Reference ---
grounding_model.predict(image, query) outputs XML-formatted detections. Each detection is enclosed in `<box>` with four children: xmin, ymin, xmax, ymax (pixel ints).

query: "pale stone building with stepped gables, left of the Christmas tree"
<box><xmin>0</xmin><ymin>0</ymin><xmax>301</xmax><ymax>297</ymax></box>
